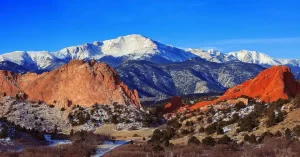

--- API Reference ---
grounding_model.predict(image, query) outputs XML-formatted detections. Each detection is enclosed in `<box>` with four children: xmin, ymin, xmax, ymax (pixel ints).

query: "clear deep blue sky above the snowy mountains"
<box><xmin>0</xmin><ymin>0</ymin><xmax>300</xmax><ymax>58</ymax></box>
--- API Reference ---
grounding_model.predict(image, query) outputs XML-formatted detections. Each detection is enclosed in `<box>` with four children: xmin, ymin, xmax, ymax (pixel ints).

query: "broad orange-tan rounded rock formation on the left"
<box><xmin>0</xmin><ymin>60</ymin><xmax>141</xmax><ymax>107</ymax></box>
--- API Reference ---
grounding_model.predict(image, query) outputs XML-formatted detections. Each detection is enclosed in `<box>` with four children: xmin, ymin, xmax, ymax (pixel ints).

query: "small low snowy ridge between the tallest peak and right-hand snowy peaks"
<box><xmin>186</xmin><ymin>48</ymin><xmax>238</xmax><ymax>63</ymax></box>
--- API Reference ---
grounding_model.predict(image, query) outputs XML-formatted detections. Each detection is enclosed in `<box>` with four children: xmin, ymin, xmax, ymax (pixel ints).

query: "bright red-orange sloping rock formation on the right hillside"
<box><xmin>191</xmin><ymin>66</ymin><xmax>300</xmax><ymax>109</ymax></box>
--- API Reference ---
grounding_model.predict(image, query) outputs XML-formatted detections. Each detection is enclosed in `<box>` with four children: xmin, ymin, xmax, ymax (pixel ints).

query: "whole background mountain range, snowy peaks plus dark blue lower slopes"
<box><xmin>0</xmin><ymin>34</ymin><xmax>300</xmax><ymax>98</ymax></box>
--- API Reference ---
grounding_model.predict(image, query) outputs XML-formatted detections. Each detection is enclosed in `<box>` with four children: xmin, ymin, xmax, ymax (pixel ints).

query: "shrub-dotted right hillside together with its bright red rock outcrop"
<box><xmin>126</xmin><ymin>66</ymin><xmax>300</xmax><ymax>157</ymax></box>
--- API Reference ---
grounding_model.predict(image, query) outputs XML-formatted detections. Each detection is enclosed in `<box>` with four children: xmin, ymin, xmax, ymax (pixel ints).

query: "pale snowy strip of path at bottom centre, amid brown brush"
<box><xmin>92</xmin><ymin>140</ymin><xmax>130</xmax><ymax>157</ymax></box>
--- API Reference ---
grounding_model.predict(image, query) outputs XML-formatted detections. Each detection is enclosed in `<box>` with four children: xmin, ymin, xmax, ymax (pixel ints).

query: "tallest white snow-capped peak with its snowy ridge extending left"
<box><xmin>0</xmin><ymin>35</ymin><xmax>197</xmax><ymax>71</ymax></box>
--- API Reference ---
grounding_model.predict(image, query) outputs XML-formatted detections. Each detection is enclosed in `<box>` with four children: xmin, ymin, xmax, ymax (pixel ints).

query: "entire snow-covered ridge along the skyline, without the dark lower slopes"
<box><xmin>0</xmin><ymin>34</ymin><xmax>300</xmax><ymax>72</ymax></box>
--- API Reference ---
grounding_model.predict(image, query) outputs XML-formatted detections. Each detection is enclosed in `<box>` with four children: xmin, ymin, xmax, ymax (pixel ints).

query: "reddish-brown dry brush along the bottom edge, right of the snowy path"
<box><xmin>105</xmin><ymin>138</ymin><xmax>300</xmax><ymax>157</ymax></box>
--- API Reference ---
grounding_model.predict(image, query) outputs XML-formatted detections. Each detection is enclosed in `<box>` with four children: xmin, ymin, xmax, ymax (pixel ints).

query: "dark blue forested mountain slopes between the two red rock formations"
<box><xmin>117</xmin><ymin>58</ymin><xmax>264</xmax><ymax>100</ymax></box>
